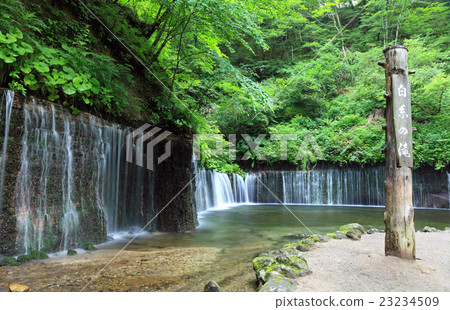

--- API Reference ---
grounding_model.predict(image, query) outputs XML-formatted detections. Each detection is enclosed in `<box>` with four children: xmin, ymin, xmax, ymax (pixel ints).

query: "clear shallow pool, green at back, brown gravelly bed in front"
<box><xmin>0</xmin><ymin>205</ymin><xmax>450</xmax><ymax>292</ymax></box>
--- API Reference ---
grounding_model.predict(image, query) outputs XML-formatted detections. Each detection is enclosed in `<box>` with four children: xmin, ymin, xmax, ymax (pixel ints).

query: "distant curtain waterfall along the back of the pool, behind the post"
<box><xmin>195</xmin><ymin>167</ymin><xmax>450</xmax><ymax>211</ymax></box>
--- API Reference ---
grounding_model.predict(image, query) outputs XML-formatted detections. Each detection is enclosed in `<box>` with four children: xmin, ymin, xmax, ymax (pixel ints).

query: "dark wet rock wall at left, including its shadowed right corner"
<box><xmin>0</xmin><ymin>90</ymin><xmax>195</xmax><ymax>255</ymax></box>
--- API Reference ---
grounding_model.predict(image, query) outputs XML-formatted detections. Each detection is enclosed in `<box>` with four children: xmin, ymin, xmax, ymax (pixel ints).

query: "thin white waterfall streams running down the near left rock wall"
<box><xmin>0</xmin><ymin>91</ymin><xmax>156</xmax><ymax>253</ymax></box>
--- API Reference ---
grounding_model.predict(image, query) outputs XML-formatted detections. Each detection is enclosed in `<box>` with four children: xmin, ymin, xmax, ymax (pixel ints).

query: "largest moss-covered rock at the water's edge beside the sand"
<box><xmin>253</xmin><ymin>247</ymin><xmax>311</xmax><ymax>285</ymax></box>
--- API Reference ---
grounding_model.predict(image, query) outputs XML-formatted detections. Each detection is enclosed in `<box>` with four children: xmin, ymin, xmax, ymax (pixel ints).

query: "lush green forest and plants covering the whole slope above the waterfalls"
<box><xmin>0</xmin><ymin>0</ymin><xmax>450</xmax><ymax>171</ymax></box>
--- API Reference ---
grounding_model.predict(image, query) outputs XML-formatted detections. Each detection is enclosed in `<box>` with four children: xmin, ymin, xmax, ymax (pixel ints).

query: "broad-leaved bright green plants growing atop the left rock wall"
<box><xmin>0</xmin><ymin>1</ymin><xmax>133</xmax><ymax>115</ymax></box>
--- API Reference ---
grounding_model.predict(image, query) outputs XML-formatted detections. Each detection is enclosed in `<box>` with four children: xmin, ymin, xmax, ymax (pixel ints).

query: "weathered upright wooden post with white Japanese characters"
<box><xmin>378</xmin><ymin>45</ymin><xmax>416</xmax><ymax>259</ymax></box>
